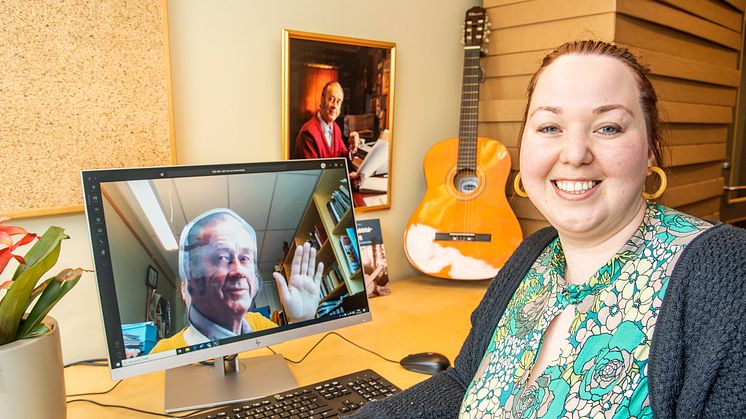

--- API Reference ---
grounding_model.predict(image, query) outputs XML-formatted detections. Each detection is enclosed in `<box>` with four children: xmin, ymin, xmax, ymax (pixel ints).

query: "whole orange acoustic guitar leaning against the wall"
<box><xmin>404</xmin><ymin>7</ymin><xmax>523</xmax><ymax>280</ymax></box>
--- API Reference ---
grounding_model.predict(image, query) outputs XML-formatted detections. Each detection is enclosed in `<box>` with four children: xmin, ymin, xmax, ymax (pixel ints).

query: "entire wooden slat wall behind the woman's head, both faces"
<box><xmin>479</xmin><ymin>0</ymin><xmax>746</xmax><ymax>235</ymax></box>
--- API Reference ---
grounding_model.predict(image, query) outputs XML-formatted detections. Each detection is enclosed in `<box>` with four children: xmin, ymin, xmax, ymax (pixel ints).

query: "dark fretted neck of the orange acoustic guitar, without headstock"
<box><xmin>458</xmin><ymin>46</ymin><xmax>480</xmax><ymax>174</ymax></box>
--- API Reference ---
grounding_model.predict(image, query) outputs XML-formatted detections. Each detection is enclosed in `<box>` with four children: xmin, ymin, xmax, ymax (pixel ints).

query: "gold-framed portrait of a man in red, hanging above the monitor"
<box><xmin>282</xmin><ymin>29</ymin><xmax>396</xmax><ymax>211</ymax></box>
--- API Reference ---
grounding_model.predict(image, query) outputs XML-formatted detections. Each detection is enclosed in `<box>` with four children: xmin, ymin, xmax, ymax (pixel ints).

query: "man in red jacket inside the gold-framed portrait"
<box><xmin>293</xmin><ymin>81</ymin><xmax>360</xmax><ymax>159</ymax></box>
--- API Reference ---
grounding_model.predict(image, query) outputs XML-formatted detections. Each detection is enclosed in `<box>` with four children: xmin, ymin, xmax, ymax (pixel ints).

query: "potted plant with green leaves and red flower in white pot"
<box><xmin>0</xmin><ymin>216</ymin><xmax>85</xmax><ymax>418</ymax></box>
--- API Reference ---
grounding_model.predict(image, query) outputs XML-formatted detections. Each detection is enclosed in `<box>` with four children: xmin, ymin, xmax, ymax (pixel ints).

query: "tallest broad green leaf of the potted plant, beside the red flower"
<box><xmin>0</xmin><ymin>241</ymin><xmax>62</xmax><ymax>346</ymax></box>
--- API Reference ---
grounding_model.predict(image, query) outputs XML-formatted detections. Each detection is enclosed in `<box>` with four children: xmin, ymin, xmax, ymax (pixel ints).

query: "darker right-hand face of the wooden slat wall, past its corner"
<box><xmin>615</xmin><ymin>0</ymin><xmax>743</xmax><ymax>219</ymax></box>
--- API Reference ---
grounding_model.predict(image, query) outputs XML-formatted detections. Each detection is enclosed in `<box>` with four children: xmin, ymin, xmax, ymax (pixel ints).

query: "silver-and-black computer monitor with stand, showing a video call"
<box><xmin>81</xmin><ymin>159</ymin><xmax>371</xmax><ymax>412</ymax></box>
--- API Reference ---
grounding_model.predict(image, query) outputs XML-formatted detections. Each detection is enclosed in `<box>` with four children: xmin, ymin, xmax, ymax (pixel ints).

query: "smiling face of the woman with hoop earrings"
<box><xmin>520</xmin><ymin>55</ymin><xmax>653</xmax><ymax>240</ymax></box>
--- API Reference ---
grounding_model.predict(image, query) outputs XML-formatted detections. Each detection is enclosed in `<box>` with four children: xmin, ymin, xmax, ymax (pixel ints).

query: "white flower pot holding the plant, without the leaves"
<box><xmin>0</xmin><ymin>317</ymin><xmax>67</xmax><ymax>419</ymax></box>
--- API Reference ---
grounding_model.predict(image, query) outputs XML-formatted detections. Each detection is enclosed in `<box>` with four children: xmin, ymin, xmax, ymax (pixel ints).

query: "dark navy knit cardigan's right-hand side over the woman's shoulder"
<box><xmin>650</xmin><ymin>223</ymin><xmax>746</xmax><ymax>417</ymax></box>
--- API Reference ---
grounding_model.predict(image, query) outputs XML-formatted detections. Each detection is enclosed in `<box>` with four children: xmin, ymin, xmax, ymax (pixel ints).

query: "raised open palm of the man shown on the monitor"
<box><xmin>272</xmin><ymin>242</ymin><xmax>324</xmax><ymax>323</ymax></box>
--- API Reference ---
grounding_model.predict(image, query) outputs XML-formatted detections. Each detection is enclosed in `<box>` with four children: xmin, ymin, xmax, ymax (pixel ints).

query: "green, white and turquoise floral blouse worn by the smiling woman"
<box><xmin>460</xmin><ymin>203</ymin><xmax>711</xmax><ymax>419</ymax></box>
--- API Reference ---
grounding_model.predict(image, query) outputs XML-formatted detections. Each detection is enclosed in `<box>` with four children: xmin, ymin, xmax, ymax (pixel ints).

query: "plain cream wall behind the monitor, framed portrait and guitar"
<box><xmin>7</xmin><ymin>0</ymin><xmax>481</xmax><ymax>362</ymax></box>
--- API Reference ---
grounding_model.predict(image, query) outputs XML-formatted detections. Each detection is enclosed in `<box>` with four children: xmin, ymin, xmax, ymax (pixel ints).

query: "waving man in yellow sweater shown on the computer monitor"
<box><xmin>150</xmin><ymin>208</ymin><xmax>324</xmax><ymax>353</ymax></box>
